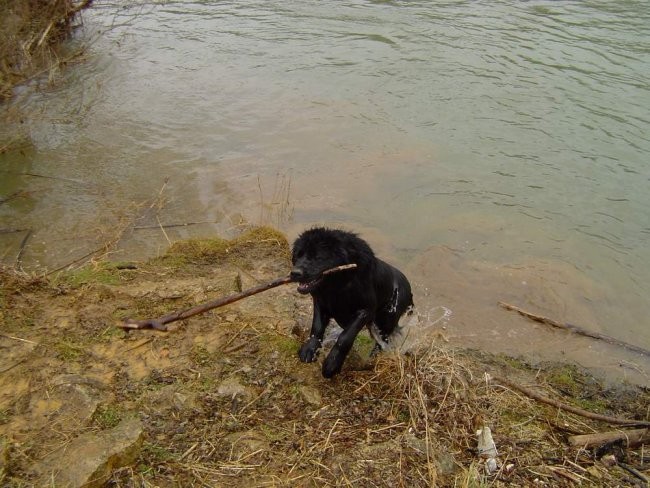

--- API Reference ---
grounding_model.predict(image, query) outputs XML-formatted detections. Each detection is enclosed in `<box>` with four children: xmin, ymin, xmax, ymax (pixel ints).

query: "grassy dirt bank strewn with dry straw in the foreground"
<box><xmin>0</xmin><ymin>228</ymin><xmax>650</xmax><ymax>487</ymax></box>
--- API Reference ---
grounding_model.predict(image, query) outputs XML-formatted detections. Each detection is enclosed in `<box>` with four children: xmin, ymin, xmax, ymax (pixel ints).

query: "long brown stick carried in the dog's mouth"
<box><xmin>118</xmin><ymin>264</ymin><xmax>357</xmax><ymax>331</ymax></box>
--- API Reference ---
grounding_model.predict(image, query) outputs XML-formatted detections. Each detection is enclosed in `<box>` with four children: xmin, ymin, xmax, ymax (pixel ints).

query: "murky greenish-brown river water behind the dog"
<box><xmin>0</xmin><ymin>0</ymin><xmax>650</xmax><ymax>382</ymax></box>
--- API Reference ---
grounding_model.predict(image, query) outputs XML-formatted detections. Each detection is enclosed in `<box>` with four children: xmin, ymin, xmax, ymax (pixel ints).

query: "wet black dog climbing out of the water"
<box><xmin>291</xmin><ymin>227</ymin><xmax>413</xmax><ymax>378</ymax></box>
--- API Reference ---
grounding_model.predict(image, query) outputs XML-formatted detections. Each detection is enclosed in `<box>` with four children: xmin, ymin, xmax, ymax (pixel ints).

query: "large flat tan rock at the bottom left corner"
<box><xmin>33</xmin><ymin>418</ymin><xmax>143</xmax><ymax>488</ymax></box>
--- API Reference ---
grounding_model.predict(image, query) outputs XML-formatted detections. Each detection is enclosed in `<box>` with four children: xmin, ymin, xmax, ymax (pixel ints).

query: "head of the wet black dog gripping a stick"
<box><xmin>291</xmin><ymin>227</ymin><xmax>374</xmax><ymax>294</ymax></box>
